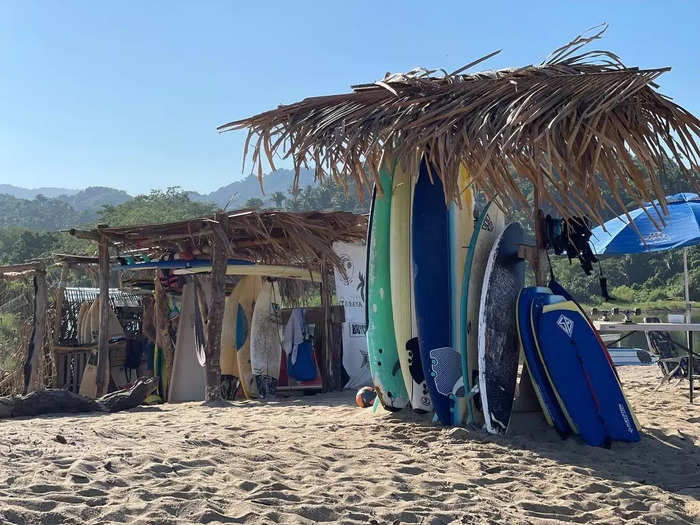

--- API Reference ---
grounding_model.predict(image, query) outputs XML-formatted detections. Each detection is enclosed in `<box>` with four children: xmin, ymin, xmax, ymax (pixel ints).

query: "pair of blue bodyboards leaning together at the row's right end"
<box><xmin>516</xmin><ymin>283</ymin><xmax>640</xmax><ymax>446</ymax></box>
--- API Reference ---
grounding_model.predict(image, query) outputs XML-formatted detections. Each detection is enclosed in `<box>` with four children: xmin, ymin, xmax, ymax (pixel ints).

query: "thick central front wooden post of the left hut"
<box><xmin>204</xmin><ymin>232</ymin><xmax>227</xmax><ymax>402</ymax></box>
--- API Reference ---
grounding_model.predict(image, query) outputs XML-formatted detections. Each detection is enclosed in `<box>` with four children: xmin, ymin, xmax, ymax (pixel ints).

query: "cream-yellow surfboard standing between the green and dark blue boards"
<box><xmin>389</xmin><ymin>160</ymin><xmax>425</xmax><ymax>410</ymax></box>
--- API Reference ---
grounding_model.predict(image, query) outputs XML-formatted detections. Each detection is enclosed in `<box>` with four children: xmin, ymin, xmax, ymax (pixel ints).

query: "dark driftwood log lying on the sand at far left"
<box><xmin>0</xmin><ymin>377</ymin><xmax>158</xmax><ymax>419</ymax></box>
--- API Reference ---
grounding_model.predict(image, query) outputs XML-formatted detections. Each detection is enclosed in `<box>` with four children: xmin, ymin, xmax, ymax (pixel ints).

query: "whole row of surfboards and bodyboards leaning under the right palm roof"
<box><xmin>365</xmin><ymin>161</ymin><xmax>634</xmax><ymax>444</ymax></box>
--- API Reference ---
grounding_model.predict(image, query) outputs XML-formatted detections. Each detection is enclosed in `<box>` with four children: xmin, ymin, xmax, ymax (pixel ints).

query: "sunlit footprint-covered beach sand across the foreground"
<box><xmin>0</xmin><ymin>367</ymin><xmax>700</xmax><ymax>524</ymax></box>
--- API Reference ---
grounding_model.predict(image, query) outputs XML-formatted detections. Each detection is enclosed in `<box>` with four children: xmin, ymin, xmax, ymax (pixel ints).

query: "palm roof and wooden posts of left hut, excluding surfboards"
<box><xmin>69</xmin><ymin>209</ymin><xmax>367</xmax><ymax>402</ymax></box>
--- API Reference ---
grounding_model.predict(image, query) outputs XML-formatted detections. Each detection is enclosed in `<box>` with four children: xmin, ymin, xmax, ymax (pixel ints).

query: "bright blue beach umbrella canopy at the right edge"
<box><xmin>590</xmin><ymin>193</ymin><xmax>700</xmax><ymax>255</ymax></box>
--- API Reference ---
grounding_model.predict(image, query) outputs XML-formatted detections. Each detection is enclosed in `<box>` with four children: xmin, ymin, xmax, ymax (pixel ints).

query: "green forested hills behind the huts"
<box><xmin>0</xmin><ymin>161</ymin><xmax>700</xmax><ymax>303</ymax></box>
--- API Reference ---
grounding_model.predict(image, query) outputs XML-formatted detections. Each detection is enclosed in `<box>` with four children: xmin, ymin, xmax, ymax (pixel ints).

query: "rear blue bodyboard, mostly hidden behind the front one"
<box><xmin>516</xmin><ymin>286</ymin><xmax>573</xmax><ymax>437</ymax></box>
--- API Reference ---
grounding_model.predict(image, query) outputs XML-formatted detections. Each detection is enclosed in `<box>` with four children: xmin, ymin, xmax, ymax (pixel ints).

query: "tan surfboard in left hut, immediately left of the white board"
<box><xmin>231</xmin><ymin>275</ymin><xmax>262</xmax><ymax>399</ymax></box>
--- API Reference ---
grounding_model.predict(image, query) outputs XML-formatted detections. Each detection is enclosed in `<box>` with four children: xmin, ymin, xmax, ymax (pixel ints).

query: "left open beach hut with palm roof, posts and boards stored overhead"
<box><xmin>70</xmin><ymin>209</ymin><xmax>367</xmax><ymax>401</ymax></box>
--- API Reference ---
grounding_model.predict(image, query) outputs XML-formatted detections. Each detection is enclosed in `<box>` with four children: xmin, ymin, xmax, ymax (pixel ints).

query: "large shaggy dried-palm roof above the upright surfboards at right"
<box><xmin>223</xmin><ymin>27</ymin><xmax>700</xmax><ymax>219</ymax></box>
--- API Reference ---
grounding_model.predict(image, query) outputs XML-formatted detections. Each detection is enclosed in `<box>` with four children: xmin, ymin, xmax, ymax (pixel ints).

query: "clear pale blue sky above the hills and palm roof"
<box><xmin>0</xmin><ymin>0</ymin><xmax>700</xmax><ymax>194</ymax></box>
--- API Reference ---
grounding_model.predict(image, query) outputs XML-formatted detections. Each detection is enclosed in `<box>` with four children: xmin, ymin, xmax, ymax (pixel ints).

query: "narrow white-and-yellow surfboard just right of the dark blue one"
<box><xmin>449</xmin><ymin>166</ymin><xmax>474</xmax><ymax>425</ymax></box>
